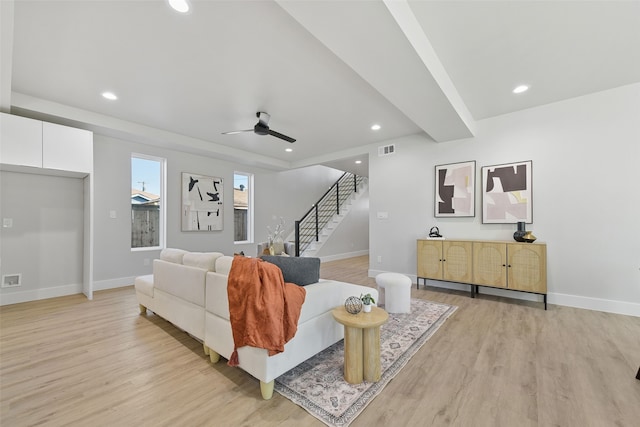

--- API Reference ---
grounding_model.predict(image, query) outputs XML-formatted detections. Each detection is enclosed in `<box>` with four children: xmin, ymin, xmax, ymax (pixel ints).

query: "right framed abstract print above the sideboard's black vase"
<box><xmin>482</xmin><ymin>160</ymin><xmax>533</xmax><ymax>224</ymax></box>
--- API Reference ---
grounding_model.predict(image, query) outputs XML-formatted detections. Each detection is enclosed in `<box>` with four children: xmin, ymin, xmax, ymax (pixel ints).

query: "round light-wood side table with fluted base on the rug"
<box><xmin>331</xmin><ymin>305</ymin><xmax>389</xmax><ymax>384</ymax></box>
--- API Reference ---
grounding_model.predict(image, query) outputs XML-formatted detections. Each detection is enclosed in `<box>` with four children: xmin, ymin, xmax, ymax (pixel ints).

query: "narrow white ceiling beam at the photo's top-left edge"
<box><xmin>0</xmin><ymin>0</ymin><xmax>14</xmax><ymax>113</ymax></box>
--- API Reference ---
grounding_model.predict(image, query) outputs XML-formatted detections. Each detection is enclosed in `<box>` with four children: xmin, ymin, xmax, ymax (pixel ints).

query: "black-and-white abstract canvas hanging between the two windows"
<box><xmin>182</xmin><ymin>172</ymin><xmax>224</xmax><ymax>231</ymax></box>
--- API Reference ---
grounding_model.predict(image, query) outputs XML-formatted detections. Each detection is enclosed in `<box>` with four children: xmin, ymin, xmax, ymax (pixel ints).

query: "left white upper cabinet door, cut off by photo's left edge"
<box><xmin>0</xmin><ymin>113</ymin><xmax>42</xmax><ymax>168</ymax></box>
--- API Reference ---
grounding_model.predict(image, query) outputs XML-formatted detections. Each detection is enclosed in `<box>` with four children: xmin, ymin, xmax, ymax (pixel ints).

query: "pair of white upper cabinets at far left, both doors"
<box><xmin>0</xmin><ymin>113</ymin><xmax>93</xmax><ymax>174</ymax></box>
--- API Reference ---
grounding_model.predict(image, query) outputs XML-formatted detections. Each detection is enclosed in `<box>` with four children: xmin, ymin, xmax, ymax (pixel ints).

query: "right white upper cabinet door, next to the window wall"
<box><xmin>42</xmin><ymin>122</ymin><xmax>93</xmax><ymax>173</ymax></box>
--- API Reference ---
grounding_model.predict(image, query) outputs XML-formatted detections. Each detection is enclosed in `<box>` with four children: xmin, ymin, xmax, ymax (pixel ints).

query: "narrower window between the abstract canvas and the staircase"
<box><xmin>233</xmin><ymin>172</ymin><xmax>253</xmax><ymax>243</ymax></box>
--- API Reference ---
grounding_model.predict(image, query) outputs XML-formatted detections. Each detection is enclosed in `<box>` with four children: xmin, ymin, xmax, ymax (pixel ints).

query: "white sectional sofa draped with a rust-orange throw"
<box><xmin>135</xmin><ymin>249</ymin><xmax>378</xmax><ymax>399</ymax></box>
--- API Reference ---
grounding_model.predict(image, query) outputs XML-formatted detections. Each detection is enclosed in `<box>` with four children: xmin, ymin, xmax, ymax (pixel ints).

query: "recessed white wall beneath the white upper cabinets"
<box><xmin>0</xmin><ymin>171</ymin><xmax>84</xmax><ymax>305</ymax></box>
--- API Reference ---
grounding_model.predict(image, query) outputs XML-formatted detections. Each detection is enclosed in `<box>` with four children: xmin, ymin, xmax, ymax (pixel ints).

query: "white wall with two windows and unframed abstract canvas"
<box><xmin>94</xmin><ymin>134</ymin><xmax>341</xmax><ymax>290</ymax></box>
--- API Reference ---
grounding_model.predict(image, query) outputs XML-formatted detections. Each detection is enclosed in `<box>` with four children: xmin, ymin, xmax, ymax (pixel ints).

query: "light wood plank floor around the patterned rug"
<box><xmin>0</xmin><ymin>257</ymin><xmax>640</xmax><ymax>427</ymax></box>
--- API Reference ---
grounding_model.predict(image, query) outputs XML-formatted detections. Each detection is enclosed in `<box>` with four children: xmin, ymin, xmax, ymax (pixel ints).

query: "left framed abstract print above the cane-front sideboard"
<box><xmin>434</xmin><ymin>161</ymin><xmax>476</xmax><ymax>217</ymax></box>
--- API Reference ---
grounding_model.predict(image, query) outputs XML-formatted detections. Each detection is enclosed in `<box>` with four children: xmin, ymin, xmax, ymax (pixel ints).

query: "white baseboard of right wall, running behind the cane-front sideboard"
<box><xmin>368</xmin><ymin>270</ymin><xmax>640</xmax><ymax>317</ymax></box>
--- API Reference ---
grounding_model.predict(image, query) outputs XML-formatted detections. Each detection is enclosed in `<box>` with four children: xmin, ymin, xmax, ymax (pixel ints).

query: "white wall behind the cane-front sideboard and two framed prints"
<box><xmin>369</xmin><ymin>84</ymin><xmax>640</xmax><ymax>315</ymax></box>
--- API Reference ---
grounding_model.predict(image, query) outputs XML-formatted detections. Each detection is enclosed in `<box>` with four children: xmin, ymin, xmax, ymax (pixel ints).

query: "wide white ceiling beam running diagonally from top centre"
<box><xmin>276</xmin><ymin>0</ymin><xmax>474</xmax><ymax>142</ymax></box>
